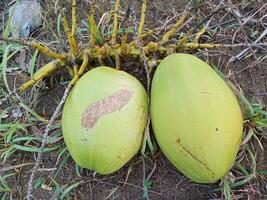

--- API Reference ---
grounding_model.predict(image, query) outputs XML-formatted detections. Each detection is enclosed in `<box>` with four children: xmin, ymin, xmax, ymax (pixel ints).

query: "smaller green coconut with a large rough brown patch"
<box><xmin>62</xmin><ymin>67</ymin><xmax>148</xmax><ymax>174</ymax></box>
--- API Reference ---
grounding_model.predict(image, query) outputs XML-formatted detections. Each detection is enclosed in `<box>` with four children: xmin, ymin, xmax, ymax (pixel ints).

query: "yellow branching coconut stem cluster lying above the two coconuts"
<box><xmin>0</xmin><ymin>0</ymin><xmax>267</xmax><ymax>92</ymax></box>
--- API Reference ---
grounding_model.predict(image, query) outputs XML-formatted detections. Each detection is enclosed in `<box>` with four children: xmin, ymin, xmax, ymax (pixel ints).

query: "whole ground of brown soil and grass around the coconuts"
<box><xmin>0</xmin><ymin>0</ymin><xmax>267</xmax><ymax>200</ymax></box>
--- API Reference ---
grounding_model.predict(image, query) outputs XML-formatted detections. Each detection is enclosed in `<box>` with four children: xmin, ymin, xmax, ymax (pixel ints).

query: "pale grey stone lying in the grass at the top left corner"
<box><xmin>9</xmin><ymin>0</ymin><xmax>43</xmax><ymax>38</ymax></box>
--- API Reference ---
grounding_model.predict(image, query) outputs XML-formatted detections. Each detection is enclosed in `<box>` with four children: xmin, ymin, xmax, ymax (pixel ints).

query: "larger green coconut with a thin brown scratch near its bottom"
<box><xmin>151</xmin><ymin>54</ymin><xmax>243</xmax><ymax>183</ymax></box>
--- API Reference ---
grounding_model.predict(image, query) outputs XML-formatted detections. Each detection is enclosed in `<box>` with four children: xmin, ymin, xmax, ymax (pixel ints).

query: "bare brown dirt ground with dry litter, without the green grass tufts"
<box><xmin>0</xmin><ymin>0</ymin><xmax>267</xmax><ymax>200</ymax></box>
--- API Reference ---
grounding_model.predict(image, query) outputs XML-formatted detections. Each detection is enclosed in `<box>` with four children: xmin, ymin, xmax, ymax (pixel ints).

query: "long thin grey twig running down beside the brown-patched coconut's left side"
<box><xmin>26</xmin><ymin>83</ymin><xmax>73</xmax><ymax>200</ymax></box>
